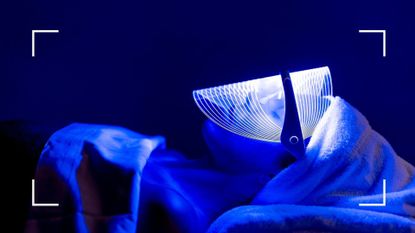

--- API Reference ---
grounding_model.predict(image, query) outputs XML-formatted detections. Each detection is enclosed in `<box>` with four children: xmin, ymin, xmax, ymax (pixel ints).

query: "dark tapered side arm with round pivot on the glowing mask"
<box><xmin>281</xmin><ymin>72</ymin><xmax>305</xmax><ymax>159</ymax></box>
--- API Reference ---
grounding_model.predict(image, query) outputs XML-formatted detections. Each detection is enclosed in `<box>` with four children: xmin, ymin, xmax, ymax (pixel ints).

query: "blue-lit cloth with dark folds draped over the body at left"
<box><xmin>25</xmin><ymin>124</ymin><xmax>165</xmax><ymax>233</ymax></box>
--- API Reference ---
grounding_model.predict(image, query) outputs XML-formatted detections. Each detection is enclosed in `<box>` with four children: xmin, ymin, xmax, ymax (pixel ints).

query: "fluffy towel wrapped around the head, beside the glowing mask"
<box><xmin>209</xmin><ymin>98</ymin><xmax>415</xmax><ymax>232</ymax></box>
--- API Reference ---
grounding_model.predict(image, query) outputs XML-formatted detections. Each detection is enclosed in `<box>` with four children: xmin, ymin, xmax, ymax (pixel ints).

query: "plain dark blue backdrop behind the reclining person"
<box><xmin>0</xmin><ymin>0</ymin><xmax>415</xmax><ymax>162</ymax></box>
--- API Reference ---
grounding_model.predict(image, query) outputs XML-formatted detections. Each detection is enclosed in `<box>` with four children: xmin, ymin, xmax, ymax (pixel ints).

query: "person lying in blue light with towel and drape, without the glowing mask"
<box><xmin>26</xmin><ymin>97</ymin><xmax>415</xmax><ymax>233</ymax></box>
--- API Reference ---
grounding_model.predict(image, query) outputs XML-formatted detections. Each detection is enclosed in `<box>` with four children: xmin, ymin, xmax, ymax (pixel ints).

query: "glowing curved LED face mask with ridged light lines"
<box><xmin>193</xmin><ymin>67</ymin><xmax>333</xmax><ymax>158</ymax></box>
